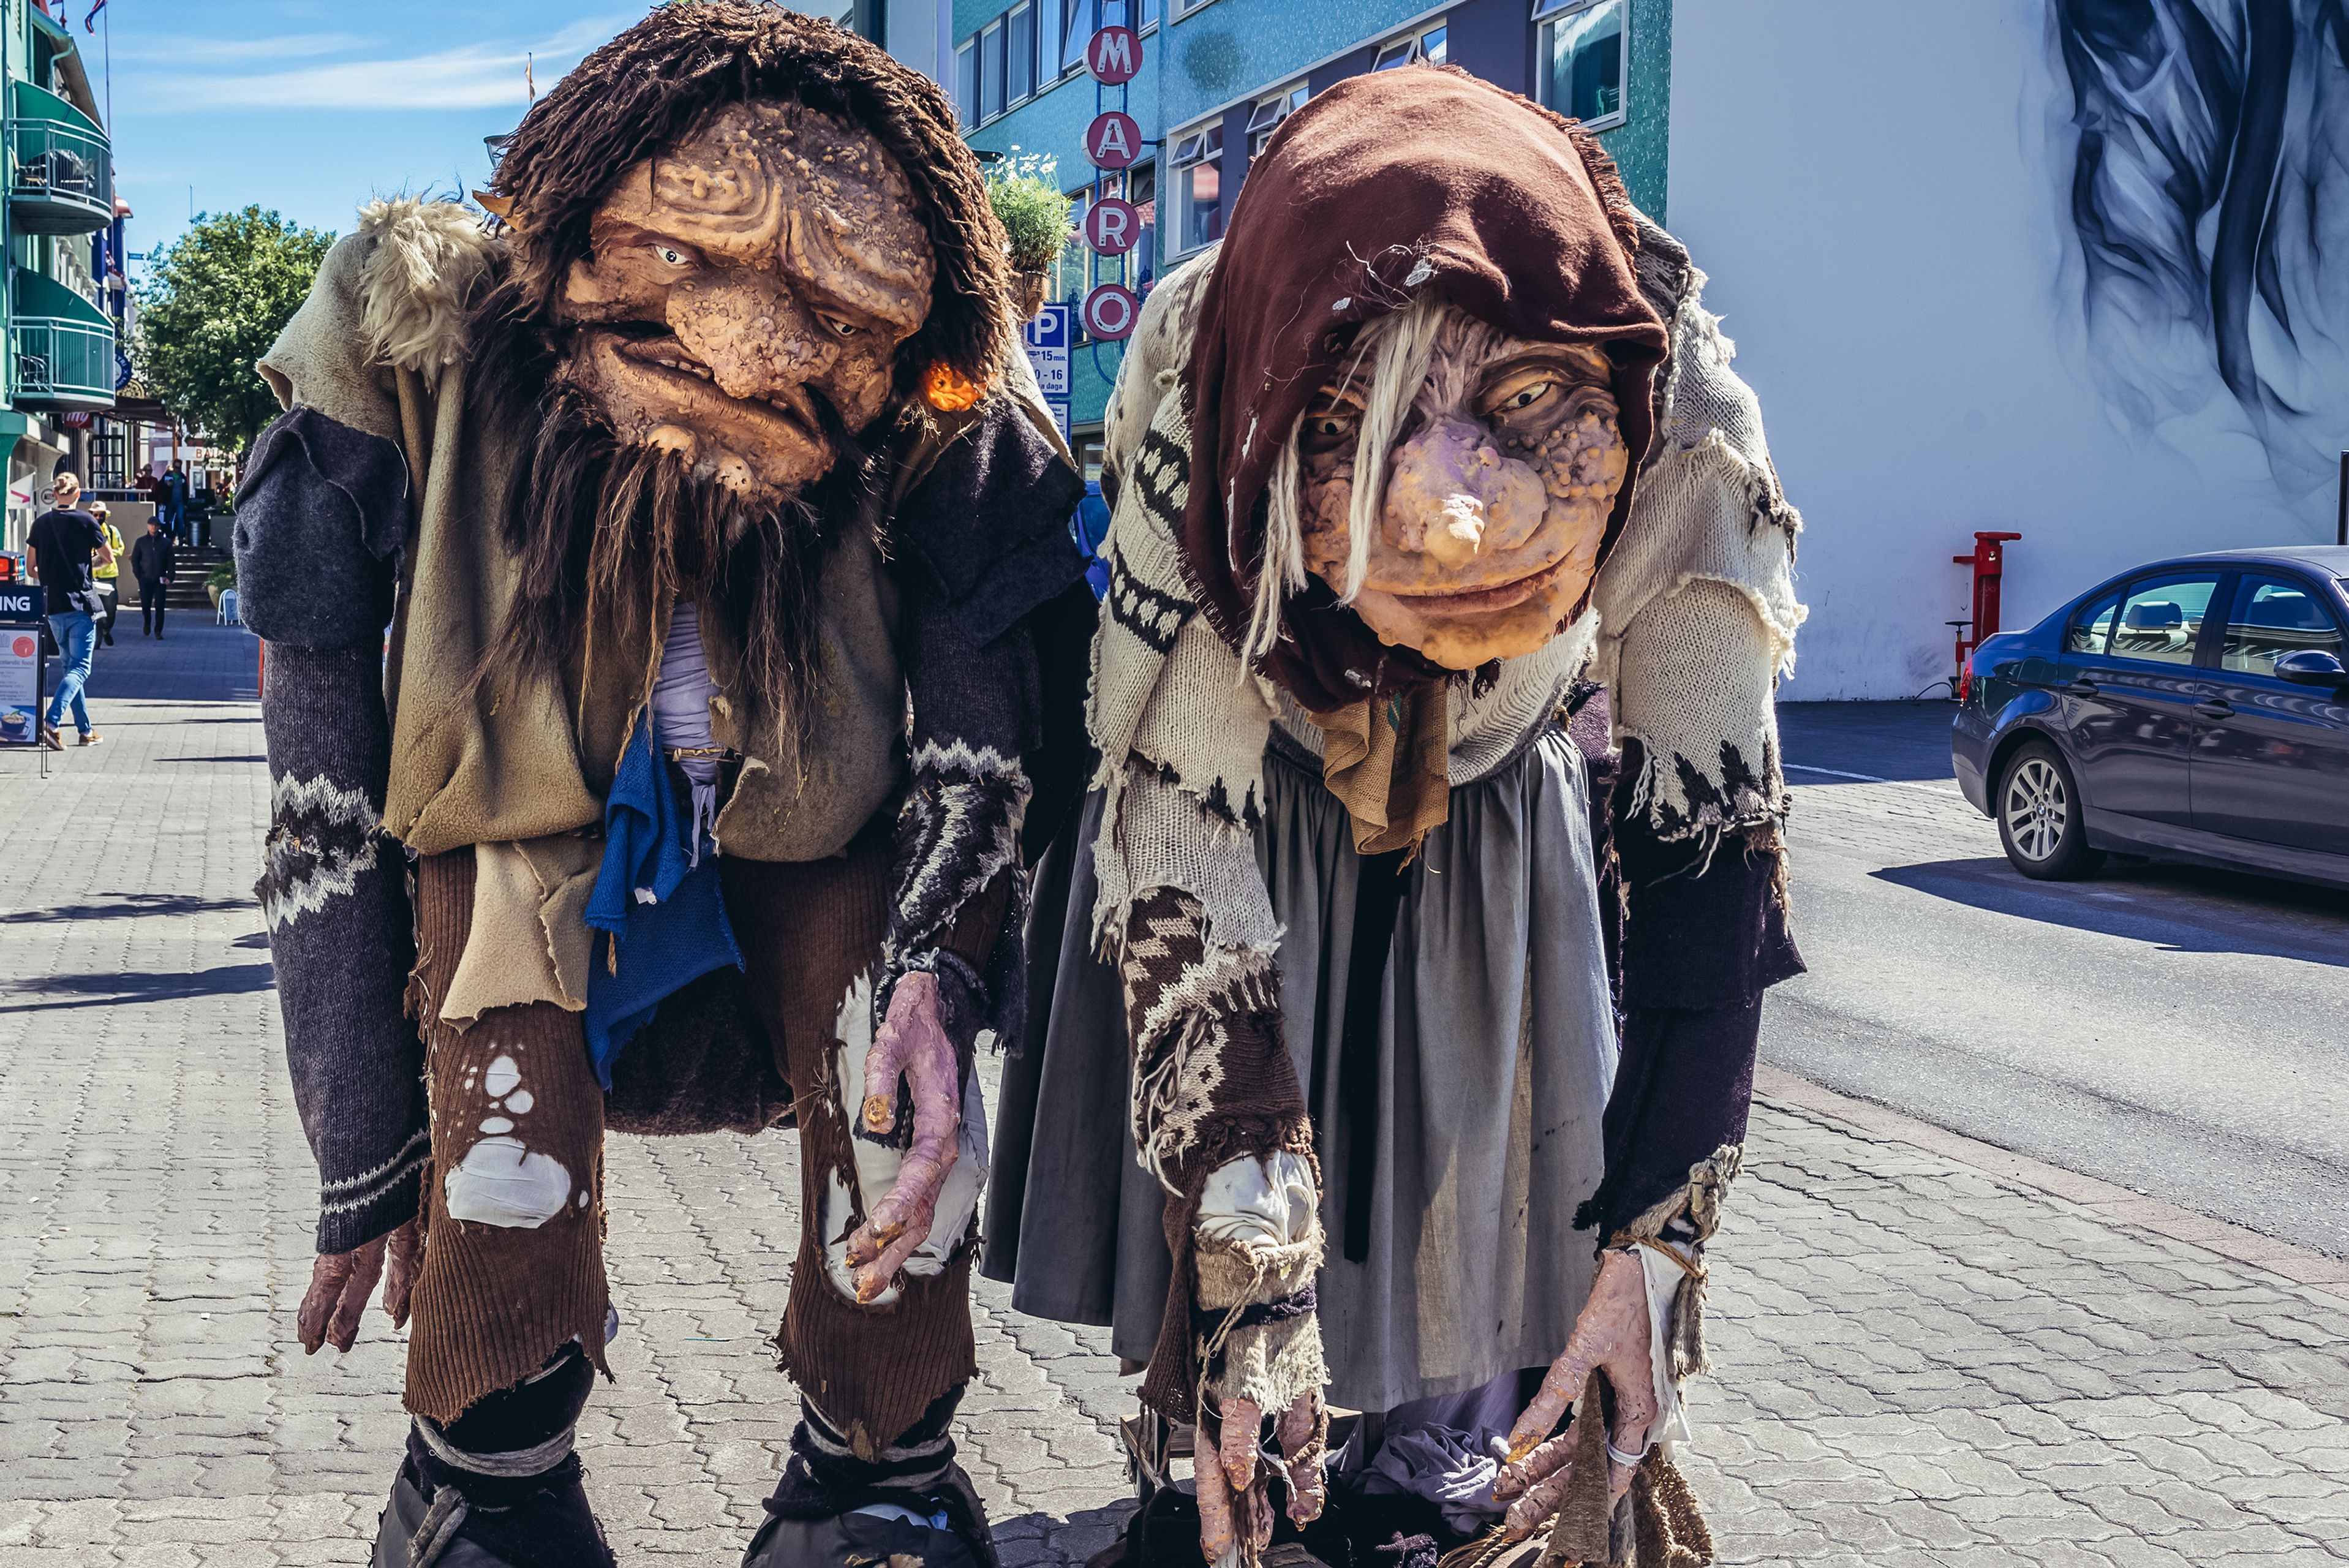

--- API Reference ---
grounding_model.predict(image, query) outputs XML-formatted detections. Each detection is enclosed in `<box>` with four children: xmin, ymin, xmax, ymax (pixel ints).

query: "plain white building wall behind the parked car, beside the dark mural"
<box><xmin>1668</xmin><ymin>0</ymin><xmax>2349</xmax><ymax>699</ymax></box>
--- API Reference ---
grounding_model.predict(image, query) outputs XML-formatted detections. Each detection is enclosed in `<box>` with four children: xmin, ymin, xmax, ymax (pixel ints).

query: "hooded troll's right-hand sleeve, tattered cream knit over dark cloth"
<box><xmin>1578</xmin><ymin>223</ymin><xmax>1804</xmax><ymax>1276</ymax></box>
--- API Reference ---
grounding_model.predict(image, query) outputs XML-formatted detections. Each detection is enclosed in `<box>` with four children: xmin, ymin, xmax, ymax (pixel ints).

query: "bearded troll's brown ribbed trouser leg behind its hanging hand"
<box><xmin>719</xmin><ymin>840</ymin><xmax>979</xmax><ymax>1460</ymax></box>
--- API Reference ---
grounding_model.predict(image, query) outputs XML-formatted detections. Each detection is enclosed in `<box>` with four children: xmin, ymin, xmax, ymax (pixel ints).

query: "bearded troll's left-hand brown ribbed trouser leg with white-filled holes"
<box><xmin>406</xmin><ymin>847</ymin><xmax>611</xmax><ymax>1425</ymax></box>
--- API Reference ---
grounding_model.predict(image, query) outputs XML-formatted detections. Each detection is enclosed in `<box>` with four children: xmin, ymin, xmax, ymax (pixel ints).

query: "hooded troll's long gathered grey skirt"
<box><xmin>979</xmin><ymin>728</ymin><xmax>1616</xmax><ymax>1411</ymax></box>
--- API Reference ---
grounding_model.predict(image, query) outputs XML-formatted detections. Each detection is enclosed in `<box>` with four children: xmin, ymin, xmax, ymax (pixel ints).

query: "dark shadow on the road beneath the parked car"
<box><xmin>1870</xmin><ymin>857</ymin><xmax>2349</xmax><ymax>970</ymax></box>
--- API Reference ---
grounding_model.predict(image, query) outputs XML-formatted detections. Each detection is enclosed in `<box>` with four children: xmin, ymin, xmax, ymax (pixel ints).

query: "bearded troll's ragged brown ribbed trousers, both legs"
<box><xmin>406</xmin><ymin>838</ymin><xmax>979</xmax><ymax>1458</ymax></box>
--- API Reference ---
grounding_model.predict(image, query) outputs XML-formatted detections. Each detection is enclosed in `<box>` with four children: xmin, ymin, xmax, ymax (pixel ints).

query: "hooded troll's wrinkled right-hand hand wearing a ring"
<box><xmin>1491</xmin><ymin>1249</ymin><xmax>1656</xmax><ymax>1540</ymax></box>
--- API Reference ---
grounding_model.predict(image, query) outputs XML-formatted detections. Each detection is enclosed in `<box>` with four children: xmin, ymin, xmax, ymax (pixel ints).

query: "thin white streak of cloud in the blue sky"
<box><xmin>123</xmin><ymin>12</ymin><xmax>634</xmax><ymax>113</ymax></box>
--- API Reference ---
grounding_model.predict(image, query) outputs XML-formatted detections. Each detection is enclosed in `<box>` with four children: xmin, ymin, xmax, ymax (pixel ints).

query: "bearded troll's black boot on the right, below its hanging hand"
<box><xmin>742</xmin><ymin>1387</ymin><xmax>998</xmax><ymax>1568</ymax></box>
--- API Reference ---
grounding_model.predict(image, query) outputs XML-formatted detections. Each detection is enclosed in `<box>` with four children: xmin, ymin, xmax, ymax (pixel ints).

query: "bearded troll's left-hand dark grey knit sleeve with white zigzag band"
<box><xmin>235</xmin><ymin>409</ymin><xmax>430</xmax><ymax>1253</ymax></box>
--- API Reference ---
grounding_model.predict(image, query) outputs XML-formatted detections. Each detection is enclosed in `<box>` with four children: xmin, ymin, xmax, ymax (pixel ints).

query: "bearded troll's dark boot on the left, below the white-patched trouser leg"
<box><xmin>371</xmin><ymin>1345</ymin><xmax>613</xmax><ymax>1568</ymax></box>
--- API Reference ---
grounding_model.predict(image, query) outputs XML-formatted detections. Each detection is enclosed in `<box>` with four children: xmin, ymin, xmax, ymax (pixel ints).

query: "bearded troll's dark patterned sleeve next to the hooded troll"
<box><xmin>874</xmin><ymin>397</ymin><xmax>1085</xmax><ymax>1058</ymax></box>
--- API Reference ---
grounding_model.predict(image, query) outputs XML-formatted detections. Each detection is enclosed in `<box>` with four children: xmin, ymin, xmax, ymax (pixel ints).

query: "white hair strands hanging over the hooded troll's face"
<box><xmin>1240</xmin><ymin>296</ymin><xmax>1454</xmax><ymax>680</ymax></box>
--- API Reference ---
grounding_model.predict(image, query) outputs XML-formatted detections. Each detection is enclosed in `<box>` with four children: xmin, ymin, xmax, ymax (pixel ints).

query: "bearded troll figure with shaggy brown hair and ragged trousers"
<box><xmin>237</xmin><ymin>0</ymin><xmax>1090</xmax><ymax>1568</ymax></box>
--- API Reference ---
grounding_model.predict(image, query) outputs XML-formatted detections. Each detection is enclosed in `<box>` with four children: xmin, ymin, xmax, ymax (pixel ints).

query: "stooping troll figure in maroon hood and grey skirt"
<box><xmin>984</xmin><ymin>66</ymin><xmax>1801</xmax><ymax>1568</ymax></box>
